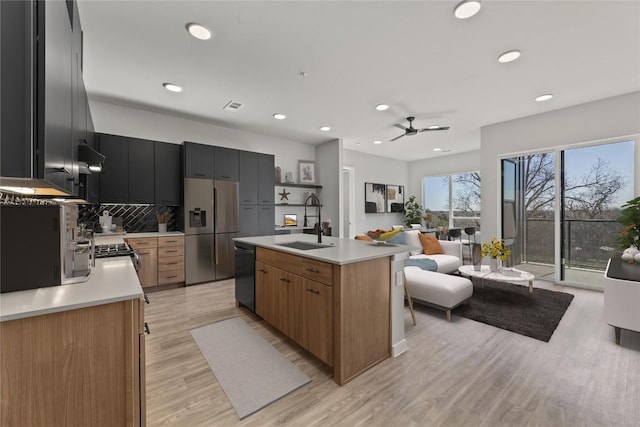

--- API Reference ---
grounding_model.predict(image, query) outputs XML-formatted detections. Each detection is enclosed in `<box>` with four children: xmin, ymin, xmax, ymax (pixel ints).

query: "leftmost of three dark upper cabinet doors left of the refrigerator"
<box><xmin>99</xmin><ymin>134</ymin><xmax>129</xmax><ymax>203</ymax></box>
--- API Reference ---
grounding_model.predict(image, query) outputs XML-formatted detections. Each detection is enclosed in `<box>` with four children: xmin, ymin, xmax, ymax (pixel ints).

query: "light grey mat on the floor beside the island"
<box><xmin>191</xmin><ymin>317</ymin><xmax>311</xmax><ymax>419</ymax></box>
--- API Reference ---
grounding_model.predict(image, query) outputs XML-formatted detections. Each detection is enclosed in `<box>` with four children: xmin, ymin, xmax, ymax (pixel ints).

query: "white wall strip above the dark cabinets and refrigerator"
<box><xmin>89</xmin><ymin>100</ymin><xmax>322</xmax><ymax>184</ymax></box>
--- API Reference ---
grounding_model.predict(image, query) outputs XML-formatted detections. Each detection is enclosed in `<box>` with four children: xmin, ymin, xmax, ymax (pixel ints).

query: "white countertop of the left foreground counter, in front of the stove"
<box><xmin>0</xmin><ymin>256</ymin><xmax>143</xmax><ymax>322</ymax></box>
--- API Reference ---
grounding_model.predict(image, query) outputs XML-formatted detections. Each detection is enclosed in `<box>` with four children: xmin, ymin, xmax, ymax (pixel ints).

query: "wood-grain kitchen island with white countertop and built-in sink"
<box><xmin>234</xmin><ymin>234</ymin><xmax>409</xmax><ymax>385</ymax></box>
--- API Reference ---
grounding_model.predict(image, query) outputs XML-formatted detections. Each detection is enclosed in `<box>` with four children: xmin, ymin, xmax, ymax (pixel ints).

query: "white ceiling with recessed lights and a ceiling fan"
<box><xmin>79</xmin><ymin>0</ymin><xmax>640</xmax><ymax>160</ymax></box>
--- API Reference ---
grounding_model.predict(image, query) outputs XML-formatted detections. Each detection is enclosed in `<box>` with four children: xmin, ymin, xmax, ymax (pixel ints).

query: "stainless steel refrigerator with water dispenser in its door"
<box><xmin>184</xmin><ymin>178</ymin><xmax>238</xmax><ymax>285</ymax></box>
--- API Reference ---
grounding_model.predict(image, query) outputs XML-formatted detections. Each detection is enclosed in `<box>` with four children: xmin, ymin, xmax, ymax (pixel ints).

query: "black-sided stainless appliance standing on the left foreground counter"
<box><xmin>0</xmin><ymin>205</ymin><xmax>91</xmax><ymax>293</ymax></box>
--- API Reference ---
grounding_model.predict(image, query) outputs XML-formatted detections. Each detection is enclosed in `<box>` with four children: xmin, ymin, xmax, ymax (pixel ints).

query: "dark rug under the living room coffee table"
<box><xmin>453</xmin><ymin>278</ymin><xmax>573</xmax><ymax>342</ymax></box>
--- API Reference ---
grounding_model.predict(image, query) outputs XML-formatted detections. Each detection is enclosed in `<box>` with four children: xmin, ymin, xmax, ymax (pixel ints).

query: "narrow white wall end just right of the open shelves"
<box><xmin>316</xmin><ymin>139</ymin><xmax>342</xmax><ymax>236</ymax></box>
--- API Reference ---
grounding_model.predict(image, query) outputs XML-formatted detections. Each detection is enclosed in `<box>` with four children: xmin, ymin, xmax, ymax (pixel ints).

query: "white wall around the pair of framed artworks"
<box><xmin>344</xmin><ymin>150</ymin><xmax>412</xmax><ymax>234</ymax></box>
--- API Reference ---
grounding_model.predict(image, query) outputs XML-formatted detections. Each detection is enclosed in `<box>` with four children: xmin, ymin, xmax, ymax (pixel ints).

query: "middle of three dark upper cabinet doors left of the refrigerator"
<box><xmin>129</xmin><ymin>138</ymin><xmax>155</xmax><ymax>204</ymax></box>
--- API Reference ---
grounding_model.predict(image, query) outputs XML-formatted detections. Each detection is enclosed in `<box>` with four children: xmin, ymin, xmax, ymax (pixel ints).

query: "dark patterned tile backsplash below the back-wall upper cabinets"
<box><xmin>78</xmin><ymin>205</ymin><xmax>179</xmax><ymax>233</ymax></box>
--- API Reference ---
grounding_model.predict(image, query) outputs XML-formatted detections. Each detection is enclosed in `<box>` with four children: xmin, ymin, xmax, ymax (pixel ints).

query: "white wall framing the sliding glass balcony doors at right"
<box><xmin>480</xmin><ymin>92</ymin><xmax>640</xmax><ymax>242</ymax></box>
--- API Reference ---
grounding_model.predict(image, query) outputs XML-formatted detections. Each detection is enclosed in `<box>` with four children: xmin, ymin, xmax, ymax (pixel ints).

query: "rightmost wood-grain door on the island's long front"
<box><xmin>302</xmin><ymin>279</ymin><xmax>333</xmax><ymax>366</ymax></box>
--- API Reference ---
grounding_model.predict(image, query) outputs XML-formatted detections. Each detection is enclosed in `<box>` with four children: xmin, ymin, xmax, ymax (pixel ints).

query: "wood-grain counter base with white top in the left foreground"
<box><xmin>0</xmin><ymin>257</ymin><xmax>145</xmax><ymax>426</ymax></box>
